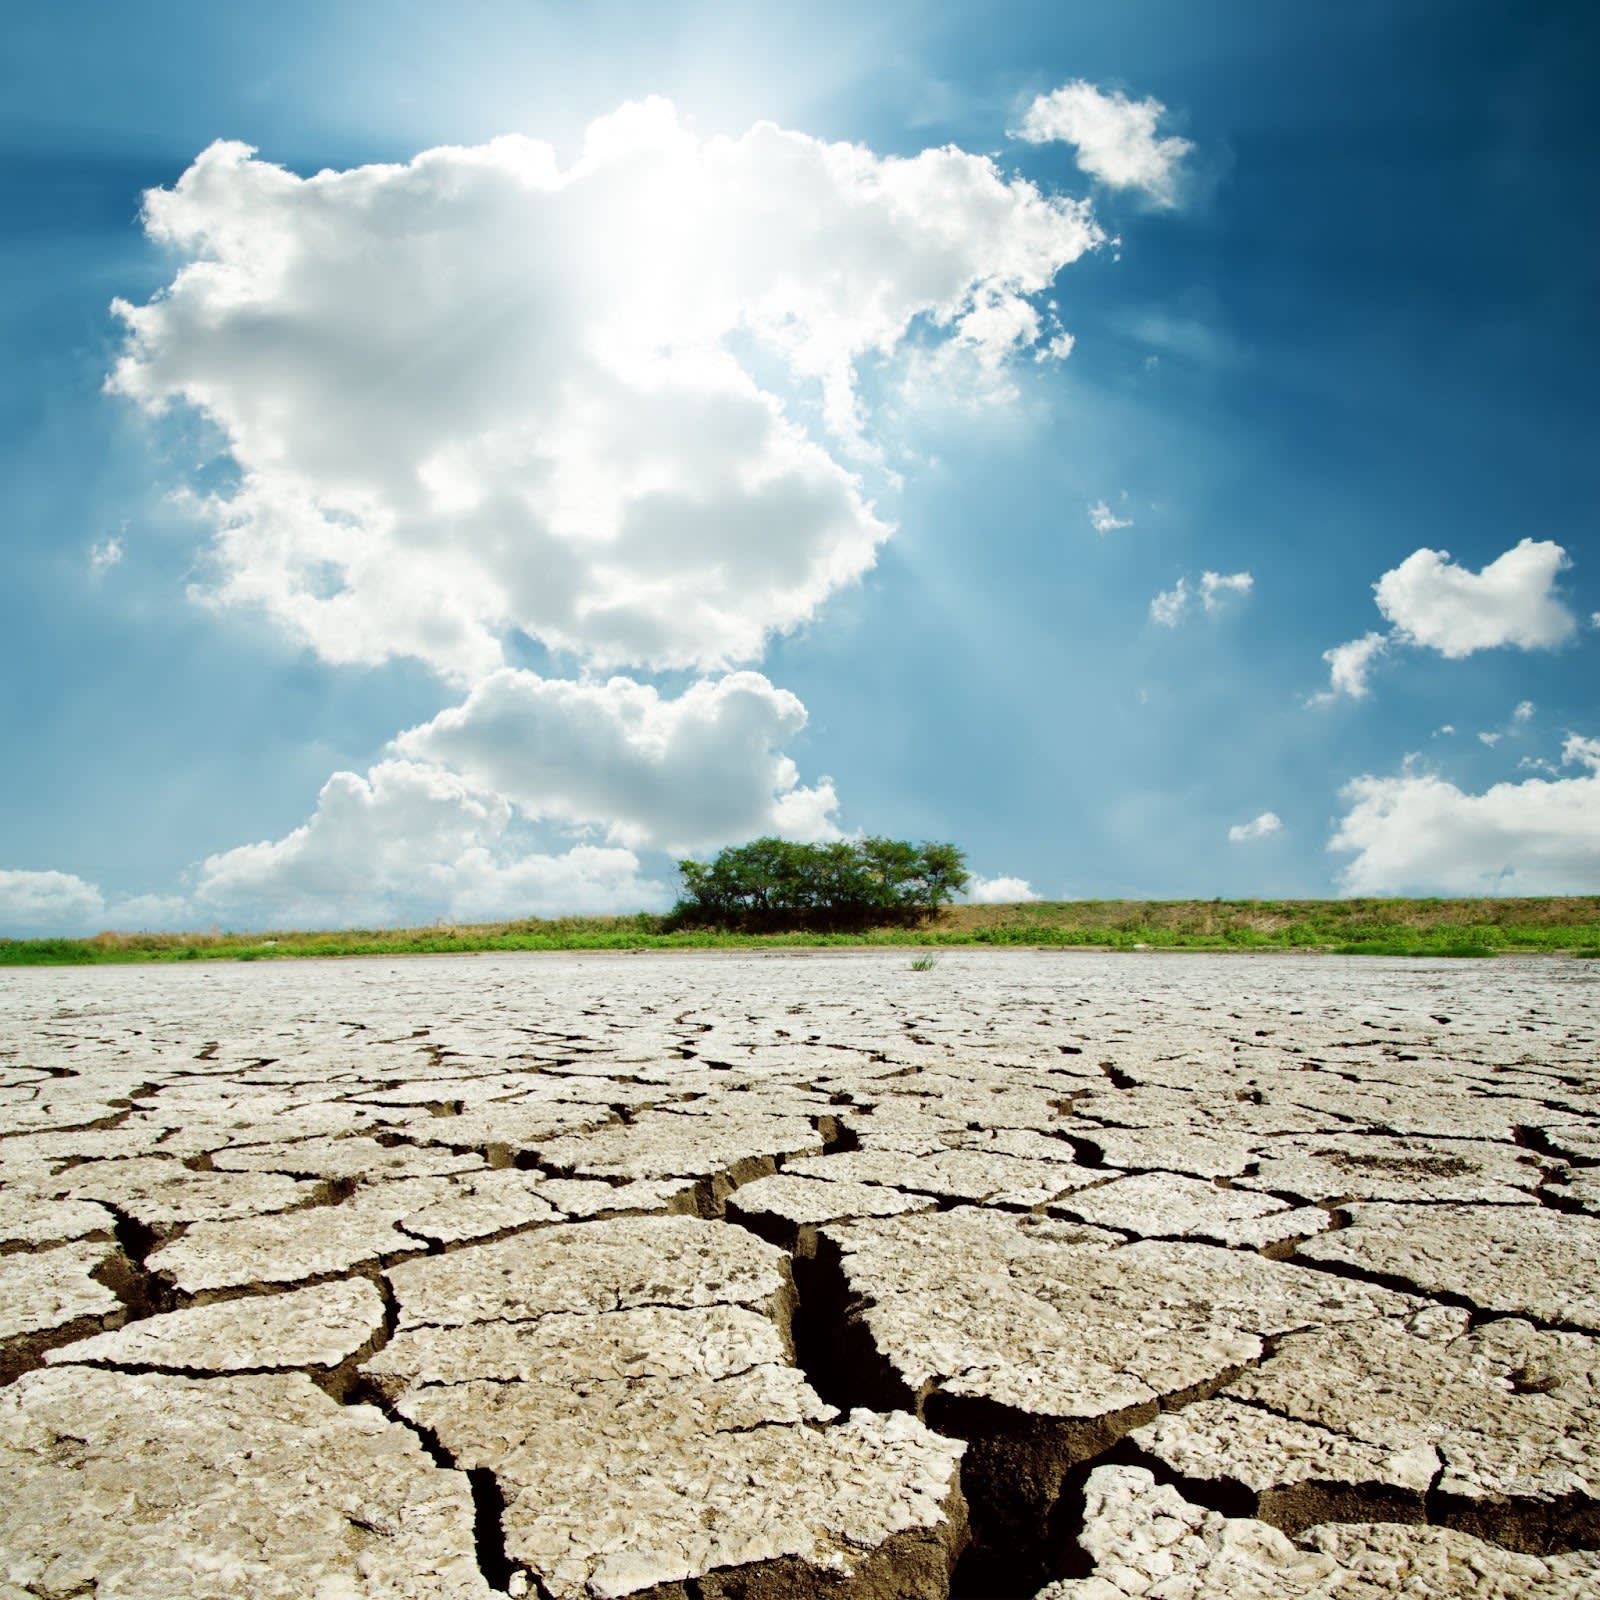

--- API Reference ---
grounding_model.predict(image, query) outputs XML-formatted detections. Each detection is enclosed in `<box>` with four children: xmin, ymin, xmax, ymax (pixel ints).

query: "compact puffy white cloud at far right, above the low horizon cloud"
<box><xmin>1373</xmin><ymin>539</ymin><xmax>1578</xmax><ymax>659</ymax></box>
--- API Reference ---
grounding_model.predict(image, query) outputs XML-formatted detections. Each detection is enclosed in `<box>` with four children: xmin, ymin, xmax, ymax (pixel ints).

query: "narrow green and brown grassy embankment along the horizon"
<box><xmin>0</xmin><ymin>894</ymin><xmax>1600</xmax><ymax>966</ymax></box>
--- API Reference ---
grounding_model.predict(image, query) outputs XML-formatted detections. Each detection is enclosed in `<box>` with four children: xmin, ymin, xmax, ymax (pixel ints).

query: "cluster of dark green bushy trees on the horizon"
<box><xmin>672</xmin><ymin>838</ymin><xmax>968</xmax><ymax>933</ymax></box>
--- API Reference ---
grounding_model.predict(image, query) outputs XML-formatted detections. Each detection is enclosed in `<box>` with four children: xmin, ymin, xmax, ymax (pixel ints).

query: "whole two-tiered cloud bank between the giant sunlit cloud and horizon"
<box><xmin>178</xmin><ymin>669</ymin><xmax>838</xmax><ymax>926</ymax></box>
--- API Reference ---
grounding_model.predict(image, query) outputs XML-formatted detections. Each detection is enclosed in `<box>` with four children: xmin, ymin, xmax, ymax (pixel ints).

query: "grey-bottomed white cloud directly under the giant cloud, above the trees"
<box><xmin>394</xmin><ymin>669</ymin><xmax>840</xmax><ymax>853</ymax></box>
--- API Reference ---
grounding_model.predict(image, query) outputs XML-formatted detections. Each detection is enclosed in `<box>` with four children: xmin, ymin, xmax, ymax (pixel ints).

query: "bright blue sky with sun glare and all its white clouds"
<box><xmin>0</xmin><ymin>0</ymin><xmax>1600</xmax><ymax>936</ymax></box>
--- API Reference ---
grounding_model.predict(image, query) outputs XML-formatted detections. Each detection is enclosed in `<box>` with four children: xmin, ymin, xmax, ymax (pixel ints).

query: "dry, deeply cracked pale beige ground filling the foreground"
<box><xmin>0</xmin><ymin>950</ymin><xmax>1600</xmax><ymax>1600</ymax></box>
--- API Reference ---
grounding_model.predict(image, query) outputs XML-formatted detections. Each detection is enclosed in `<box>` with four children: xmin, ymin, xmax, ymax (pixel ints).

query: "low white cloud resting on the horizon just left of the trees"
<box><xmin>194</xmin><ymin>762</ymin><xmax>669</xmax><ymax>928</ymax></box>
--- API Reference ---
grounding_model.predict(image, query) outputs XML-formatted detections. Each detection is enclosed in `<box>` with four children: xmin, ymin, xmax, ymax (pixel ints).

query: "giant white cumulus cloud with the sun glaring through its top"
<box><xmin>109</xmin><ymin>101</ymin><xmax>1102</xmax><ymax>682</ymax></box>
